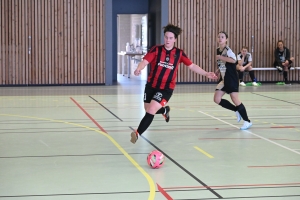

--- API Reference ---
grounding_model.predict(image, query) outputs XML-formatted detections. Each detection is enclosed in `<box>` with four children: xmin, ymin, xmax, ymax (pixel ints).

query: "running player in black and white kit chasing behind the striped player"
<box><xmin>214</xmin><ymin>31</ymin><xmax>252</xmax><ymax>130</ymax></box>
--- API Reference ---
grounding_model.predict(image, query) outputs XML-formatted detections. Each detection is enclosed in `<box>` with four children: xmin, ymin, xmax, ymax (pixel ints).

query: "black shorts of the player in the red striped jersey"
<box><xmin>144</xmin><ymin>84</ymin><xmax>173</xmax><ymax>106</ymax></box>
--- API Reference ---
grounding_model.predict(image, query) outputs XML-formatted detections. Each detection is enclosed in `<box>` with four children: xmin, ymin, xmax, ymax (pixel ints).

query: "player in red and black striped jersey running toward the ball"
<box><xmin>130</xmin><ymin>24</ymin><xmax>218</xmax><ymax>144</ymax></box>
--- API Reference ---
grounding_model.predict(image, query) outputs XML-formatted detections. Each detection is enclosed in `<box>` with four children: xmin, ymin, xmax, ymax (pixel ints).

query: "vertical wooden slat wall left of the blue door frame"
<box><xmin>0</xmin><ymin>0</ymin><xmax>105</xmax><ymax>85</ymax></box>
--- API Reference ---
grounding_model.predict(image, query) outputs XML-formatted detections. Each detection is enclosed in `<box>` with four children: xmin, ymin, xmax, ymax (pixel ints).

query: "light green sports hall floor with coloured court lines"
<box><xmin>0</xmin><ymin>76</ymin><xmax>300</xmax><ymax>200</ymax></box>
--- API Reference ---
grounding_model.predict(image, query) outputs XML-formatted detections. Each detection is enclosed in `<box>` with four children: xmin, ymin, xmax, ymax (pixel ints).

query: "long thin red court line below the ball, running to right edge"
<box><xmin>163</xmin><ymin>182</ymin><xmax>300</xmax><ymax>190</ymax></box>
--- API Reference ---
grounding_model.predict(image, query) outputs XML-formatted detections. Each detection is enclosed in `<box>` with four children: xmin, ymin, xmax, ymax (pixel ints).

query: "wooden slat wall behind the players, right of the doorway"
<box><xmin>169</xmin><ymin>0</ymin><xmax>300</xmax><ymax>82</ymax></box>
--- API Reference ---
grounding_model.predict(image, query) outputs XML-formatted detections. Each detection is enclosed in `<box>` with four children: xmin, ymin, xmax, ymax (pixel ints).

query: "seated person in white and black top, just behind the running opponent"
<box><xmin>236</xmin><ymin>46</ymin><xmax>258</xmax><ymax>86</ymax></box>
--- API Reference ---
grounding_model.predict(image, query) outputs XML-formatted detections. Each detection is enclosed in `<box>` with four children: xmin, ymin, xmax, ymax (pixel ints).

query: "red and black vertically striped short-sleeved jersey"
<box><xmin>144</xmin><ymin>45</ymin><xmax>193</xmax><ymax>90</ymax></box>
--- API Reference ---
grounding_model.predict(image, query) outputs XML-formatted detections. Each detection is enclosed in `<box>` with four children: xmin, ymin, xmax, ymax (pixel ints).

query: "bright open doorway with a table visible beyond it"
<box><xmin>117</xmin><ymin>14</ymin><xmax>148</xmax><ymax>84</ymax></box>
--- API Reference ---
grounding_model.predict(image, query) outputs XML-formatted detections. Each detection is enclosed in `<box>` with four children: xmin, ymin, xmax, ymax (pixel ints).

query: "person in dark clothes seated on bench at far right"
<box><xmin>274</xmin><ymin>40</ymin><xmax>294</xmax><ymax>84</ymax></box>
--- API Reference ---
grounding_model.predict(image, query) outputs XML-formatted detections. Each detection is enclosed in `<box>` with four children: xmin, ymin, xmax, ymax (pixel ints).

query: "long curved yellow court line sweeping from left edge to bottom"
<box><xmin>0</xmin><ymin>114</ymin><xmax>156</xmax><ymax>200</ymax></box>
